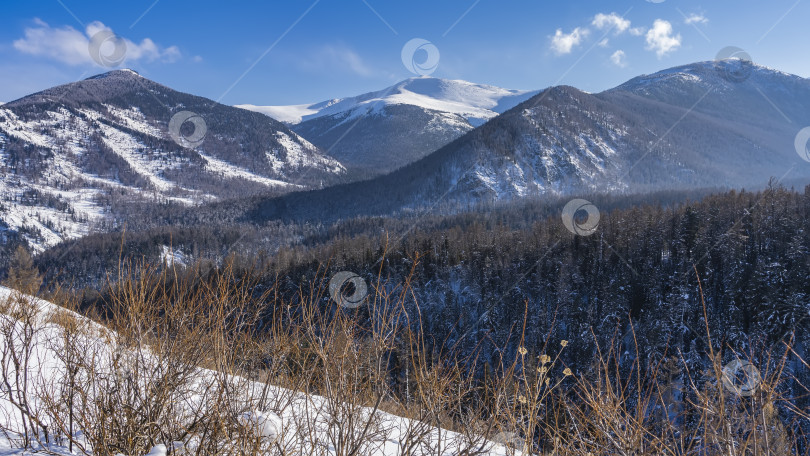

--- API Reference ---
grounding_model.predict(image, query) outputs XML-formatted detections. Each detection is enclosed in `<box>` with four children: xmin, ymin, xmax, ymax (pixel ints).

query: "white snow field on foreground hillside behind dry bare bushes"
<box><xmin>0</xmin><ymin>287</ymin><xmax>520</xmax><ymax>456</ymax></box>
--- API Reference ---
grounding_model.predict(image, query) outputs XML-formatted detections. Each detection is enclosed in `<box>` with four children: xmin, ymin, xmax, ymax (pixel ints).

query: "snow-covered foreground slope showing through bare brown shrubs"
<box><xmin>0</xmin><ymin>287</ymin><xmax>520</xmax><ymax>456</ymax></box>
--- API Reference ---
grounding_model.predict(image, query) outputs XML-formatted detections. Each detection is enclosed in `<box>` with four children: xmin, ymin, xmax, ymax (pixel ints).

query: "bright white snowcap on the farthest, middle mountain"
<box><xmin>236</xmin><ymin>77</ymin><xmax>538</xmax><ymax>126</ymax></box>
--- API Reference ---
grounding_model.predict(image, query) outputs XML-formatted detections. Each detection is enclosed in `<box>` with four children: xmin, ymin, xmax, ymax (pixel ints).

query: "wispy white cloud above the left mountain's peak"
<box><xmin>14</xmin><ymin>19</ymin><xmax>180</xmax><ymax>65</ymax></box>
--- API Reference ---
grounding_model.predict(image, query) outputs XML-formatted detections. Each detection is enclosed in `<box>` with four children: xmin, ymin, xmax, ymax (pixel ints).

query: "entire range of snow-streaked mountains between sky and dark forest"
<box><xmin>0</xmin><ymin>60</ymin><xmax>810</xmax><ymax>250</ymax></box>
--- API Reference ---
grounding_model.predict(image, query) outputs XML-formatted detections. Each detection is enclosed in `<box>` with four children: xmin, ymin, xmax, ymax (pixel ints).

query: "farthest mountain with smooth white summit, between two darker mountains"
<box><xmin>238</xmin><ymin>77</ymin><xmax>537</xmax><ymax>176</ymax></box>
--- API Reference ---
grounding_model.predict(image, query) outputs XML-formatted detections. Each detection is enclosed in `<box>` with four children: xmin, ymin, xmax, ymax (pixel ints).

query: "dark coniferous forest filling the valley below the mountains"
<box><xmin>26</xmin><ymin>183</ymin><xmax>810</xmax><ymax>448</ymax></box>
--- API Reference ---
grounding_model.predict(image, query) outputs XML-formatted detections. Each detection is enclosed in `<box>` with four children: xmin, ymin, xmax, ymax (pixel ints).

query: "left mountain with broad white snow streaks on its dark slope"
<box><xmin>0</xmin><ymin>70</ymin><xmax>346</xmax><ymax>248</ymax></box>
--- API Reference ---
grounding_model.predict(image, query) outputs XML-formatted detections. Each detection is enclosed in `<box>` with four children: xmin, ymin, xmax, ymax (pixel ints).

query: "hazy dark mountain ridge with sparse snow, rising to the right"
<box><xmin>252</xmin><ymin>60</ymin><xmax>810</xmax><ymax>224</ymax></box>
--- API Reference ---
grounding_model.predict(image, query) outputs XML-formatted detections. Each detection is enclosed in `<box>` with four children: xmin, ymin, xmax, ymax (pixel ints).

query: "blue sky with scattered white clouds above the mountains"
<box><xmin>0</xmin><ymin>0</ymin><xmax>810</xmax><ymax>105</ymax></box>
